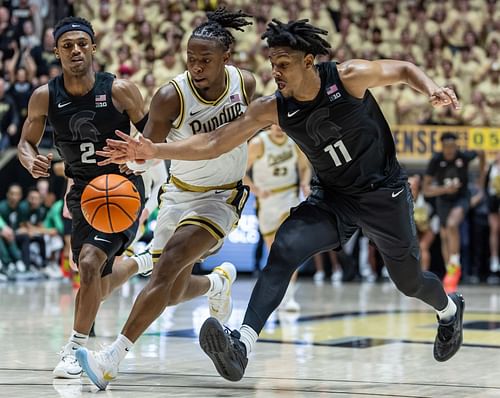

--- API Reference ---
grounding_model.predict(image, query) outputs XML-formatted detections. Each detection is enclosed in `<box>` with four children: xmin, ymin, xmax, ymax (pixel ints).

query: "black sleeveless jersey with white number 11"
<box><xmin>276</xmin><ymin>62</ymin><xmax>401</xmax><ymax>193</ymax></box>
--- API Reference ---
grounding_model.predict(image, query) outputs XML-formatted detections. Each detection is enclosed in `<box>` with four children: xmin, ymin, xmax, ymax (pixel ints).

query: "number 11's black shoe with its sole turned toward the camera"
<box><xmin>200</xmin><ymin>318</ymin><xmax>248</xmax><ymax>381</ymax></box>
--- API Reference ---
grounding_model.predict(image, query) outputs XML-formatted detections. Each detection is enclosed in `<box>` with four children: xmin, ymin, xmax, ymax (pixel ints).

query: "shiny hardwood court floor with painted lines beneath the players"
<box><xmin>0</xmin><ymin>278</ymin><xmax>500</xmax><ymax>398</ymax></box>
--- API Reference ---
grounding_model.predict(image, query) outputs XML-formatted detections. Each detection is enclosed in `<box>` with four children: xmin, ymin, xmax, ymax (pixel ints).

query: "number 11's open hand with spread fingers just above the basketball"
<box><xmin>96</xmin><ymin>130</ymin><xmax>156</xmax><ymax>166</ymax></box>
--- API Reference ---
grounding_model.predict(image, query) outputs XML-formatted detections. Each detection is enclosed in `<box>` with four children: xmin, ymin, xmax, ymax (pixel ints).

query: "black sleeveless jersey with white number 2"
<box><xmin>48</xmin><ymin>72</ymin><xmax>130</xmax><ymax>183</ymax></box>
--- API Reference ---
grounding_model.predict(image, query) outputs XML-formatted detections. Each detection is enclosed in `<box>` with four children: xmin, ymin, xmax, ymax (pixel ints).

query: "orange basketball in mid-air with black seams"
<box><xmin>81</xmin><ymin>174</ymin><xmax>141</xmax><ymax>233</ymax></box>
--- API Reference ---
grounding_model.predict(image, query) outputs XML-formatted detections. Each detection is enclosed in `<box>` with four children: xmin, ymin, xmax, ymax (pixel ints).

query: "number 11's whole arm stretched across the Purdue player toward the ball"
<box><xmin>99</xmin><ymin>96</ymin><xmax>278</xmax><ymax>163</ymax></box>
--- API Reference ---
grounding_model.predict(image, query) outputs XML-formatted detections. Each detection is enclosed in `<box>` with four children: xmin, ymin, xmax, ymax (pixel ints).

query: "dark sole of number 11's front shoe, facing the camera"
<box><xmin>199</xmin><ymin>318</ymin><xmax>243</xmax><ymax>381</ymax></box>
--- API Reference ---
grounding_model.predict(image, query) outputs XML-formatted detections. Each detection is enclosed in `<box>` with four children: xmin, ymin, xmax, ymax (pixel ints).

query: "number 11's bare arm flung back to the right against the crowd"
<box><xmin>338</xmin><ymin>59</ymin><xmax>460</xmax><ymax>109</ymax></box>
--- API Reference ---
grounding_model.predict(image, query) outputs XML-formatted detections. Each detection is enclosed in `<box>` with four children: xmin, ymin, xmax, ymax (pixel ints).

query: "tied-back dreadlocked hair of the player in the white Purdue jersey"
<box><xmin>191</xmin><ymin>7</ymin><xmax>252</xmax><ymax>51</ymax></box>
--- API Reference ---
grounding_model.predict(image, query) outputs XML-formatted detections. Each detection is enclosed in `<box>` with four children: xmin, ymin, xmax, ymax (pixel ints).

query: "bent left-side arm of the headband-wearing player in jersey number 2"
<box><xmin>17</xmin><ymin>84</ymin><xmax>53</xmax><ymax>178</ymax></box>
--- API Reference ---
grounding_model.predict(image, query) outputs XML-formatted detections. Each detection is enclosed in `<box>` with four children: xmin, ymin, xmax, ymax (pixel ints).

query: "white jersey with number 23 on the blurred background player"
<box><xmin>252</xmin><ymin>131</ymin><xmax>299</xmax><ymax>192</ymax></box>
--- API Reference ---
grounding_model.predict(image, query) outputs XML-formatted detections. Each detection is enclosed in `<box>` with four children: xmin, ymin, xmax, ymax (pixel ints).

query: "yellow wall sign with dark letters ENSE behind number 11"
<box><xmin>392</xmin><ymin>125</ymin><xmax>500</xmax><ymax>162</ymax></box>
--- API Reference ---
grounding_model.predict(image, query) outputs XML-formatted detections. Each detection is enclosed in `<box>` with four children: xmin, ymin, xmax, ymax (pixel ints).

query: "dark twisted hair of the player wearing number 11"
<box><xmin>261</xmin><ymin>18</ymin><xmax>331</xmax><ymax>56</ymax></box>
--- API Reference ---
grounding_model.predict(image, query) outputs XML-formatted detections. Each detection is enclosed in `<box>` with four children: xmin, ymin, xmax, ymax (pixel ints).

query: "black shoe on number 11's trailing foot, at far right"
<box><xmin>434</xmin><ymin>293</ymin><xmax>465</xmax><ymax>362</ymax></box>
